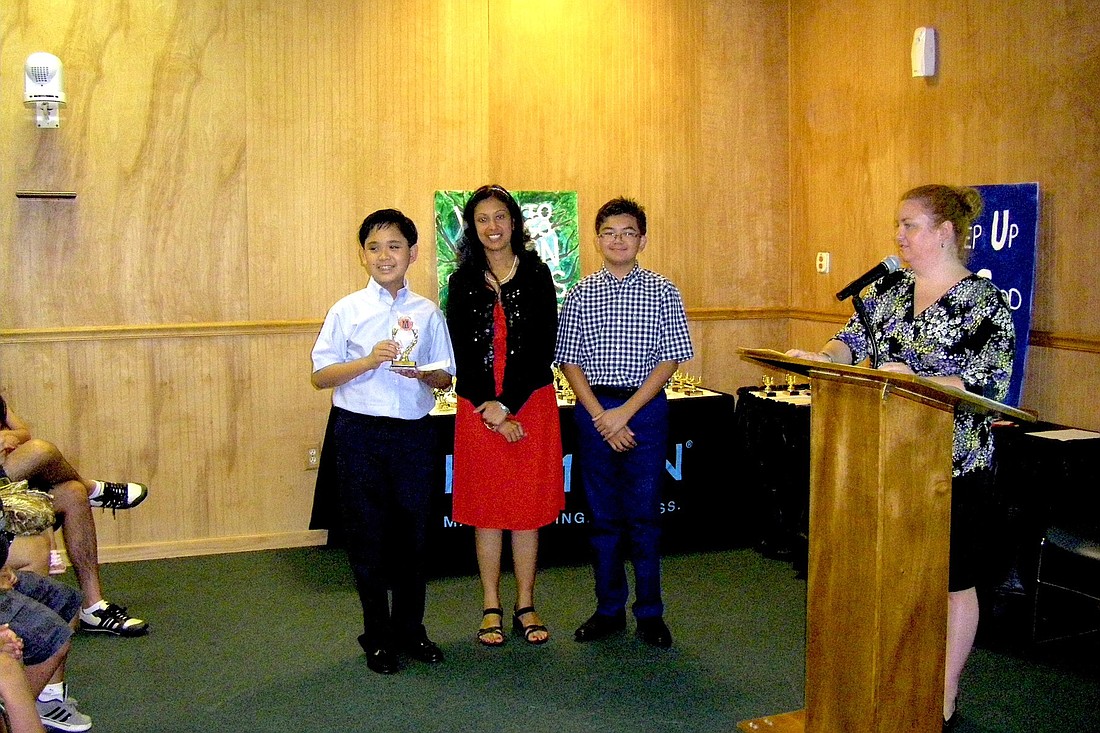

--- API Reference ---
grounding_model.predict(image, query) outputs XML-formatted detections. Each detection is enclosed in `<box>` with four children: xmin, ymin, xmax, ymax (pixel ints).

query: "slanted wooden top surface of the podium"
<box><xmin>737</xmin><ymin>348</ymin><xmax>1035</xmax><ymax>423</ymax></box>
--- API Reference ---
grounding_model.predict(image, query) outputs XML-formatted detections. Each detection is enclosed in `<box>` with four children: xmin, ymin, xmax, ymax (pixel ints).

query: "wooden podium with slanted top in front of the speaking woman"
<box><xmin>738</xmin><ymin>349</ymin><xmax>1034</xmax><ymax>733</ymax></box>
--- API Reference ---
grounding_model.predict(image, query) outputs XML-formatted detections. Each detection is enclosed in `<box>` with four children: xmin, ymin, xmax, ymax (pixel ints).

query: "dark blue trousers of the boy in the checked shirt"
<box><xmin>573</xmin><ymin>392</ymin><xmax>669</xmax><ymax>619</ymax></box>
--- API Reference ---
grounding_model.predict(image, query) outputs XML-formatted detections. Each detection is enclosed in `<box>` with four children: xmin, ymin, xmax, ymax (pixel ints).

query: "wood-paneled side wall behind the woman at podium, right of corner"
<box><xmin>790</xmin><ymin>0</ymin><xmax>1100</xmax><ymax>429</ymax></box>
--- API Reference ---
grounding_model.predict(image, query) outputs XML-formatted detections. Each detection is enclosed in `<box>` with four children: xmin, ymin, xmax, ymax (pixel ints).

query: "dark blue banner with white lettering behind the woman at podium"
<box><xmin>968</xmin><ymin>183</ymin><xmax>1038</xmax><ymax>406</ymax></box>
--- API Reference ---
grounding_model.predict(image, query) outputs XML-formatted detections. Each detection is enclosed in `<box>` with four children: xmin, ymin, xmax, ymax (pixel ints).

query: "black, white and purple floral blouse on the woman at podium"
<box><xmin>834</xmin><ymin>269</ymin><xmax>1016</xmax><ymax>477</ymax></box>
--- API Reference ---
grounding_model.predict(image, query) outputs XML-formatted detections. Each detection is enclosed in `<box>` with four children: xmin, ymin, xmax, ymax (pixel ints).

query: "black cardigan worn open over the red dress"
<box><xmin>447</xmin><ymin>252</ymin><xmax>558</xmax><ymax>414</ymax></box>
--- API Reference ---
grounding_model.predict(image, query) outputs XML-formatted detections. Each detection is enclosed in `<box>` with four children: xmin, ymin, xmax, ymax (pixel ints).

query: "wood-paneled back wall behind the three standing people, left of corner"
<box><xmin>0</xmin><ymin>0</ymin><xmax>789</xmax><ymax>560</ymax></box>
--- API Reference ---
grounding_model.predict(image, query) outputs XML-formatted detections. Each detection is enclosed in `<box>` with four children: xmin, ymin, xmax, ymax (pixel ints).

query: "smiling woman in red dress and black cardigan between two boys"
<box><xmin>447</xmin><ymin>186</ymin><xmax>565</xmax><ymax>646</ymax></box>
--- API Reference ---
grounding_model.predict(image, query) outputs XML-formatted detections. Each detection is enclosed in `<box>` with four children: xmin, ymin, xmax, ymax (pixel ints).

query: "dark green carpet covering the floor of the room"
<box><xmin>62</xmin><ymin>548</ymin><xmax>1100</xmax><ymax>733</ymax></box>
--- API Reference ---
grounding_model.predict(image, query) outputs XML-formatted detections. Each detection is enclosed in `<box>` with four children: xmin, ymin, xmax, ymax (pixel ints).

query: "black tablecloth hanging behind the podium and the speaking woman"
<box><xmin>735</xmin><ymin>386</ymin><xmax>1100</xmax><ymax>610</ymax></box>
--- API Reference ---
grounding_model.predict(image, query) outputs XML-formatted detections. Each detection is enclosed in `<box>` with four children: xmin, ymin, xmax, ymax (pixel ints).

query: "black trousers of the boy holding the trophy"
<box><xmin>332</xmin><ymin>407</ymin><xmax>436</xmax><ymax>650</ymax></box>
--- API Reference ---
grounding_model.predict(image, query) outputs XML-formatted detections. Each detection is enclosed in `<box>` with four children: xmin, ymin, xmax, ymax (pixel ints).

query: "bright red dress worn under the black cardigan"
<box><xmin>452</xmin><ymin>300</ymin><xmax>565</xmax><ymax>529</ymax></box>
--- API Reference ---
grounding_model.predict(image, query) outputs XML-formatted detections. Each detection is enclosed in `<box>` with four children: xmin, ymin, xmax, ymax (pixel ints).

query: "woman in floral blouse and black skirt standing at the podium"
<box><xmin>788</xmin><ymin>184</ymin><xmax>1015</xmax><ymax>731</ymax></box>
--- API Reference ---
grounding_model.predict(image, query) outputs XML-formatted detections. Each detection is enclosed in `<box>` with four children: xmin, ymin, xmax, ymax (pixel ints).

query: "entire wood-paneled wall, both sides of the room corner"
<box><xmin>0</xmin><ymin>0</ymin><xmax>1100</xmax><ymax>560</ymax></box>
